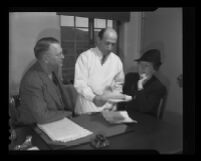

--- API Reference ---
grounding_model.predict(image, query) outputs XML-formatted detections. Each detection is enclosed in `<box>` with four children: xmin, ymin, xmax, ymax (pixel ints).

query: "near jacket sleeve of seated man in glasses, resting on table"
<box><xmin>21</xmin><ymin>74</ymin><xmax>70</xmax><ymax>124</ymax></box>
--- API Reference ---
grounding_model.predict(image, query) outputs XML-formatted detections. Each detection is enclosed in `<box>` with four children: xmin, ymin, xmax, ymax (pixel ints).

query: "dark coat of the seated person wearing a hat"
<box><xmin>119</xmin><ymin>73</ymin><xmax>166</xmax><ymax>116</ymax></box>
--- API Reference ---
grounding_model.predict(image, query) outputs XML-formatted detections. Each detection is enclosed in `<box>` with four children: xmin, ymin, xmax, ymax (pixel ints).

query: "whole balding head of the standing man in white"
<box><xmin>98</xmin><ymin>28</ymin><xmax>117</xmax><ymax>55</ymax></box>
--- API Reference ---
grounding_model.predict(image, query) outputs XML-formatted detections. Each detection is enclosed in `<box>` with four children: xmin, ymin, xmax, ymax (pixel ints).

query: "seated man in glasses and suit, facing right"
<box><xmin>18</xmin><ymin>37</ymin><xmax>73</xmax><ymax>124</ymax></box>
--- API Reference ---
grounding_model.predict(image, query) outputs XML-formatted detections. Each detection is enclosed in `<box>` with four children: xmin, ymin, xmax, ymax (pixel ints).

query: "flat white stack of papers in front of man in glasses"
<box><xmin>37</xmin><ymin>118</ymin><xmax>93</xmax><ymax>142</ymax></box>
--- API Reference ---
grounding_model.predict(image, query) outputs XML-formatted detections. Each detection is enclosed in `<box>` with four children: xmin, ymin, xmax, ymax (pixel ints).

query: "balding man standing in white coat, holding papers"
<box><xmin>74</xmin><ymin>28</ymin><xmax>124</xmax><ymax>115</ymax></box>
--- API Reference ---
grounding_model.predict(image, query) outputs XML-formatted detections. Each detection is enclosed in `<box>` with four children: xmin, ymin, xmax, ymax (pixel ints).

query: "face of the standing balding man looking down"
<box><xmin>99</xmin><ymin>32</ymin><xmax>117</xmax><ymax>56</ymax></box>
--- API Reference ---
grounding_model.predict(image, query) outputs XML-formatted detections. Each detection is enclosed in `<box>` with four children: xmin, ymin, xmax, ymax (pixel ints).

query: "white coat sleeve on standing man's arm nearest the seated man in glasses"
<box><xmin>74</xmin><ymin>55</ymin><xmax>95</xmax><ymax>101</ymax></box>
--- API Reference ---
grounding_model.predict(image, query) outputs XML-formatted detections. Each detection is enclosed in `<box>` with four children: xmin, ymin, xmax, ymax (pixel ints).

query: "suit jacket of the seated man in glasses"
<box><xmin>18</xmin><ymin>62</ymin><xmax>74</xmax><ymax>124</ymax></box>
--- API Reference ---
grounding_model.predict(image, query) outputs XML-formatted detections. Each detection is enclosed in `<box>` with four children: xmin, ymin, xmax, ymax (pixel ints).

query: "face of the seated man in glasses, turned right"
<box><xmin>47</xmin><ymin>43</ymin><xmax>64</xmax><ymax>68</ymax></box>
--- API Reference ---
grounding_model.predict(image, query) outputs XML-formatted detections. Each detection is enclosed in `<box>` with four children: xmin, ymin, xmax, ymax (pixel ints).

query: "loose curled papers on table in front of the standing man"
<box><xmin>102</xmin><ymin>111</ymin><xmax>137</xmax><ymax>124</ymax></box>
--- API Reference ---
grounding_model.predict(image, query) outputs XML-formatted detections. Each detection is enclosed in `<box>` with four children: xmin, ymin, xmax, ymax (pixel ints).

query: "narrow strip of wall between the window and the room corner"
<box><xmin>119</xmin><ymin>12</ymin><xmax>142</xmax><ymax>73</ymax></box>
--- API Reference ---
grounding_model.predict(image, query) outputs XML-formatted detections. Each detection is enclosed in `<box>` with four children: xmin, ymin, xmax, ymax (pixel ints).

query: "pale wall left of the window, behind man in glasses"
<box><xmin>9</xmin><ymin>12</ymin><xmax>60</xmax><ymax>94</ymax></box>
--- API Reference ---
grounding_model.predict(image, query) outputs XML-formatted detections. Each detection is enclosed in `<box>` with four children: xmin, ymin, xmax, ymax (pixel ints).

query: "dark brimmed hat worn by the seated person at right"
<box><xmin>134</xmin><ymin>49</ymin><xmax>161</xmax><ymax>65</ymax></box>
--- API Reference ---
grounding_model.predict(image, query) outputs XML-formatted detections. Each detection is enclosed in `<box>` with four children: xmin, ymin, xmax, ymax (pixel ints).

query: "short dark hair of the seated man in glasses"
<box><xmin>34</xmin><ymin>37</ymin><xmax>59</xmax><ymax>59</ymax></box>
